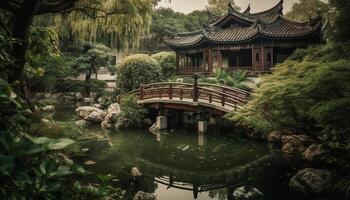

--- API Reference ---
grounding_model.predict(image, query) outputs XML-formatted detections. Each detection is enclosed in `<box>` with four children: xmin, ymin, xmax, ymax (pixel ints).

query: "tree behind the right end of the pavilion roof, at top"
<box><xmin>286</xmin><ymin>0</ymin><xmax>329</xmax><ymax>21</ymax></box>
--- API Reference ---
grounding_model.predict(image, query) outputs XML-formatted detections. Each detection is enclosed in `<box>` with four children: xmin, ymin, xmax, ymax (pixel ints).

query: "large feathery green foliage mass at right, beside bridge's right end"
<box><xmin>231</xmin><ymin>44</ymin><xmax>350</xmax><ymax>167</ymax></box>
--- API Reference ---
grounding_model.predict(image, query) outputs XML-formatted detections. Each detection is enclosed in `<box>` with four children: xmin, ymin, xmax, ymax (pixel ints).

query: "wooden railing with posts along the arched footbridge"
<box><xmin>119</xmin><ymin>81</ymin><xmax>250</xmax><ymax>110</ymax></box>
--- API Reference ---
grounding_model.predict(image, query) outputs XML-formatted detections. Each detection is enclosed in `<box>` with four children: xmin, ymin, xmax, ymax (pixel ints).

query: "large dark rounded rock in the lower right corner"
<box><xmin>289</xmin><ymin>168</ymin><xmax>332</xmax><ymax>197</ymax></box>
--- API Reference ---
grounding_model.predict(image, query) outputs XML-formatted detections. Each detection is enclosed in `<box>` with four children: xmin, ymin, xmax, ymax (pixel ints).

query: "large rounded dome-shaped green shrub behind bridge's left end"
<box><xmin>116</xmin><ymin>54</ymin><xmax>161</xmax><ymax>94</ymax></box>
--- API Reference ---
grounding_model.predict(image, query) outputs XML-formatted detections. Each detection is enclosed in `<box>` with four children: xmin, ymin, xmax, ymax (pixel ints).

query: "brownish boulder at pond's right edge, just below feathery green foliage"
<box><xmin>281</xmin><ymin>135</ymin><xmax>313</xmax><ymax>154</ymax></box>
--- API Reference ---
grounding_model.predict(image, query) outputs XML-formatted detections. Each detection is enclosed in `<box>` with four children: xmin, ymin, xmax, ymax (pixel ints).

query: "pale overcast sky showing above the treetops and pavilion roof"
<box><xmin>159</xmin><ymin>0</ymin><xmax>297</xmax><ymax>13</ymax></box>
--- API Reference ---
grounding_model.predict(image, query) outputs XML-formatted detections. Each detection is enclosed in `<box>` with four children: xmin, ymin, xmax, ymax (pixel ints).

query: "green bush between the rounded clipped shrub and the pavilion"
<box><xmin>151</xmin><ymin>51</ymin><xmax>176</xmax><ymax>79</ymax></box>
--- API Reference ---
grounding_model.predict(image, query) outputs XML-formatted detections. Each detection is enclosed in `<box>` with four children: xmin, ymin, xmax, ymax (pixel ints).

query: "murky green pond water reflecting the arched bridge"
<box><xmin>54</xmin><ymin>102</ymin><xmax>290</xmax><ymax>200</ymax></box>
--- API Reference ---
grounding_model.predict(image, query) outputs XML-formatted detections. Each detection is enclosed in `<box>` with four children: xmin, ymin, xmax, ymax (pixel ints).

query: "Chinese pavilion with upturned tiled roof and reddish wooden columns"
<box><xmin>166</xmin><ymin>0</ymin><xmax>322</xmax><ymax>74</ymax></box>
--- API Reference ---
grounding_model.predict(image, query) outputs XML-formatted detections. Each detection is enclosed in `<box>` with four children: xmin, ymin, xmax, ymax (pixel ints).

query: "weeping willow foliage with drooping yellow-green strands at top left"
<box><xmin>35</xmin><ymin>0</ymin><xmax>156</xmax><ymax>50</ymax></box>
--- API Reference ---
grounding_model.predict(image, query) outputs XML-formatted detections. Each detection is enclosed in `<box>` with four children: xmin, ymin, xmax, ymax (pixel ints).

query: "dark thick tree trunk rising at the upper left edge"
<box><xmin>8</xmin><ymin>0</ymin><xmax>41</xmax><ymax>84</ymax></box>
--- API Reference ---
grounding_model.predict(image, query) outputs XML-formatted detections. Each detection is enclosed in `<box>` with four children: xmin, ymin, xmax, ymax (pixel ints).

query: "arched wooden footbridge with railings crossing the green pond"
<box><xmin>121</xmin><ymin>81</ymin><xmax>250</xmax><ymax>115</ymax></box>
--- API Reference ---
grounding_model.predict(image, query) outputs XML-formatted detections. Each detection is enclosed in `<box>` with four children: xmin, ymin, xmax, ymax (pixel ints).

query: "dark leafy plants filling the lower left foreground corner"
<box><xmin>0</xmin><ymin>79</ymin><xmax>122</xmax><ymax>199</ymax></box>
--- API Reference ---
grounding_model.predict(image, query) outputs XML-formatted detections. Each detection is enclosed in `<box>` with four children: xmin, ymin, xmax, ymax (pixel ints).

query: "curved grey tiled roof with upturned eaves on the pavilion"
<box><xmin>165</xmin><ymin>0</ymin><xmax>322</xmax><ymax>48</ymax></box>
